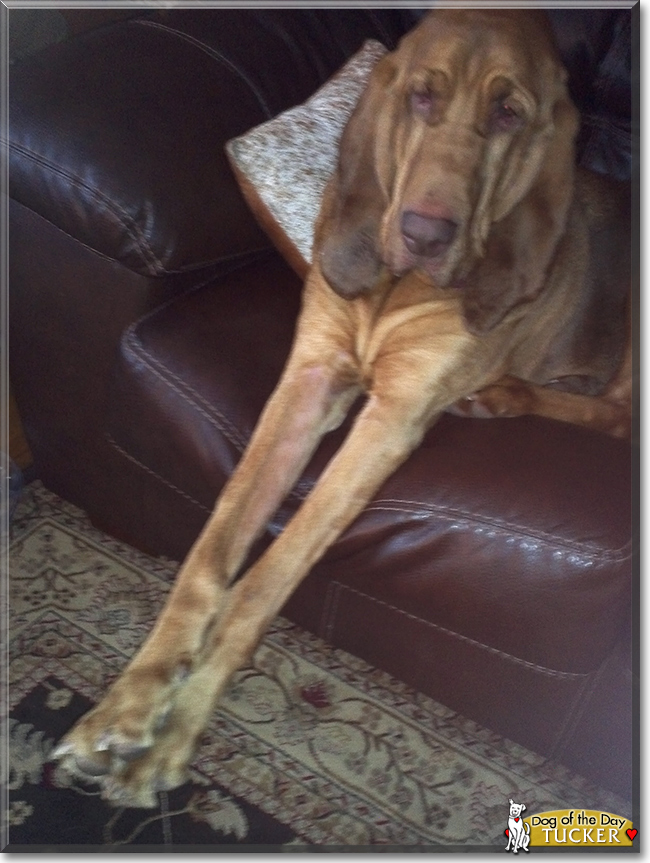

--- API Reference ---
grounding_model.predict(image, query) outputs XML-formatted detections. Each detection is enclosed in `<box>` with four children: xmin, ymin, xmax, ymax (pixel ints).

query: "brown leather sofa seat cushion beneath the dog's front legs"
<box><xmin>109</xmin><ymin>255</ymin><xmax>630</xmax><ymax>688</ymax></box>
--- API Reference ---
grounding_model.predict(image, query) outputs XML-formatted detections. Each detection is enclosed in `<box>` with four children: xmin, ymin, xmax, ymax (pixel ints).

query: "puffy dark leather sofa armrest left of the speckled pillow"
<box><xmin>9</xmin><ymin>19</ymin><xmax>274</xmax><ymax>276</ymax></box>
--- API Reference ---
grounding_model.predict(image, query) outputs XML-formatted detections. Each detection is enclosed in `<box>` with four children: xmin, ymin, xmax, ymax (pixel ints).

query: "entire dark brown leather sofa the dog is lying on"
<box><xmin>10</xmin><ymin>9</ymin><xmax>637</xmax><ymax>797</ymax></box>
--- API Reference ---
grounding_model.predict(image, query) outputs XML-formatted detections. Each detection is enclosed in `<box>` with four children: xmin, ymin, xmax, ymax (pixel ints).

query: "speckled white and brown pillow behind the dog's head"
<box><xmin>226</xmin><ymin>40</ymin><xmax>387</xmax><ymax>278</ymax></box>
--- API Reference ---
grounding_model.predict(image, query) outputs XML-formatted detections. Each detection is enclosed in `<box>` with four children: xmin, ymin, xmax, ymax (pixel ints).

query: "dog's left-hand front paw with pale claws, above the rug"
<box><xmin>51</xmin><ymin>662</ymin><xmax>188</xmax><ymax>781</ymax></box>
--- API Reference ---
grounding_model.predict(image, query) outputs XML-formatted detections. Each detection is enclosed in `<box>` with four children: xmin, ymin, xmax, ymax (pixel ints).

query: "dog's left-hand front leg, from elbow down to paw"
<box><xmin>53</xmin><ymin>340</ymin><xmax>359</xmax><ymax>806</ymax></box>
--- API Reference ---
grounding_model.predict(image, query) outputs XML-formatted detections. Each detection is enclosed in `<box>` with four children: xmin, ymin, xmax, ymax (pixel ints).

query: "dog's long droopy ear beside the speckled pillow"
<box><xmin>315</xmin><ymin>55</ymin><xmax>395</xmax><ymax>299</ymax></box>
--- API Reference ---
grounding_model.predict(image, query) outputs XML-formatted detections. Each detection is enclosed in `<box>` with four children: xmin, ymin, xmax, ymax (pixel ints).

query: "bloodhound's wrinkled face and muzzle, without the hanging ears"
<box><xmin>380</xmin><ymin>10</ymin><xmax>564</xmax><ymax>286</ymax></box>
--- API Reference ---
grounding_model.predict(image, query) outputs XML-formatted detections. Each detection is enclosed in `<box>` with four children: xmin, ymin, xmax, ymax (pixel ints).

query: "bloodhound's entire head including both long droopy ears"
<box><xmin>320</xmin><ymin>9</ymin><xmax>576</xmax><ymax>329</ymax></box>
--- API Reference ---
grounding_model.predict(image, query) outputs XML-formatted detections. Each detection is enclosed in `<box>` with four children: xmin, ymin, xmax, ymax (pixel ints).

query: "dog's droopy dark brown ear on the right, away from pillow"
<box><xmin>463</xmin><ymin>94</ymin><xmax>578</xmax><ymax>334</ymax></box>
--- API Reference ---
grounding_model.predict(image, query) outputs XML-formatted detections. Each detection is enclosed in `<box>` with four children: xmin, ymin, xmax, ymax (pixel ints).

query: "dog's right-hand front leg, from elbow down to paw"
<box><xmin>106</xmin><ymin>374</ymin><xmax>450</xmax><ymax>805</ymax></box>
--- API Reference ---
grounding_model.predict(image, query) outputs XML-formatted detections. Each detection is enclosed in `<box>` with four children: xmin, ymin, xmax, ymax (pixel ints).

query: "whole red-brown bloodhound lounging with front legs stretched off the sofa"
<box><xmin>55</xmin><ymin>9</ymin><xmax>631</xmax><ymax>806</ymax></box>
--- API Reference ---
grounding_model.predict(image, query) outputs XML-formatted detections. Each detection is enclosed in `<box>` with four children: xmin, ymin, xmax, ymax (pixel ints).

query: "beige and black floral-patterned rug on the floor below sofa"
<box><xmin>5</xmin><ymin>483</ymin><xmax>630</xmax><ymax>851</ymax></box>
